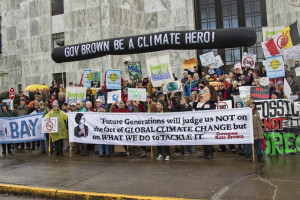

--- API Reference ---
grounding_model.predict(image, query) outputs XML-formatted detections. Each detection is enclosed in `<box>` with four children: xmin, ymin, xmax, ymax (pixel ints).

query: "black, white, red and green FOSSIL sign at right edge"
<box><xmin>255</xmin><ymin>99</ymin><xmax>300</xmax><ymax>155</ymax></box>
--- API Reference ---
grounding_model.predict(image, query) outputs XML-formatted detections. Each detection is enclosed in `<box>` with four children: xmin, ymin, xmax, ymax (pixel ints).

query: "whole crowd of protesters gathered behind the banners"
<box><xmin>0</xmin><ymin>61</ymin><xmax>300</xmax><ymax>162</ymax></box>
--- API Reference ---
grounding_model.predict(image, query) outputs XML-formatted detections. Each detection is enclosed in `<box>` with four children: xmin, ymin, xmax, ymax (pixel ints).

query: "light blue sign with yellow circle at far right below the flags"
<box><xmin>266</xmin><ymin>55</ymin><xmax>285</xmax><ymax>79</ymax></box>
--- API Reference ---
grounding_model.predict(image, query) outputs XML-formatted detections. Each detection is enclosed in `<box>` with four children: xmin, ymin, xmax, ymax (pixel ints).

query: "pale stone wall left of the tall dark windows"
<box><xmin>0</xmin><ymin>0</ymin><xmax>196</xmax><ymax>92</ymax></box>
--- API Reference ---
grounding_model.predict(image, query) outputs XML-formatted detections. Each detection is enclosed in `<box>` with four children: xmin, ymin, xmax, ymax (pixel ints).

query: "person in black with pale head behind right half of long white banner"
<box><xmin>193</xmin><ymin>85</ymin><xmax>218</xmax><ymax>160</ymax></box>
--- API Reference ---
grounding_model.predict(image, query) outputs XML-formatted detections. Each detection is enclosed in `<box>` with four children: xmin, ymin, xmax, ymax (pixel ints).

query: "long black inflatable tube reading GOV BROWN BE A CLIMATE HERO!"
<box><xmin>52</xmin><ymin>27</ymin><xmax>256</xmax><ymax>63</ymax></box>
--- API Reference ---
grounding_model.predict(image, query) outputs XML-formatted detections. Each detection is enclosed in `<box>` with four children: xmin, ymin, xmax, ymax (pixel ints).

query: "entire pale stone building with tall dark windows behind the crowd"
<box><xmin>0</xmin><ymin>0</ymin><xmax>300</xmax><ymax>92</ymax></box>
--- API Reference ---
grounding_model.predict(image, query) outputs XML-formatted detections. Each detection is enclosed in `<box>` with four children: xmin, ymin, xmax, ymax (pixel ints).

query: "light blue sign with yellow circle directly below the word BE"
<box><xmin>106</xmin><ymin>69</ymin><xmax>121</xmax><ymax>90</ymax></box>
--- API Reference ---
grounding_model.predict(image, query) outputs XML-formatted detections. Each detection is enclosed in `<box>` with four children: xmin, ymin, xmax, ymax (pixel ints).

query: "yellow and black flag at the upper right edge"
<box><xmin>281</xmin><ymin>22</ymin><xmax>300</xmax><ymax>49</ymax></box>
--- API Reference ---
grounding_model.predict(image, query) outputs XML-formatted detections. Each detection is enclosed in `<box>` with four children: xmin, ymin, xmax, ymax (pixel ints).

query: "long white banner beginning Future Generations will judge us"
<box><xmin>67</xmin><ymin>108</ymin><xmax>253</xmax><ymax>146</ymax></box>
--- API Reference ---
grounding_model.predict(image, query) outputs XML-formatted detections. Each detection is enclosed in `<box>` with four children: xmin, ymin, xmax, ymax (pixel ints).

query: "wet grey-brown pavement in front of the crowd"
<box><xmin>0</xmin><ymin>150</ymin><xmax>300</xmax><ymax>200</ymax></box>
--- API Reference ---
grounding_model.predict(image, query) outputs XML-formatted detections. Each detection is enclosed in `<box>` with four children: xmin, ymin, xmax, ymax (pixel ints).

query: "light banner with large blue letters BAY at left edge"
<box><xmin>0</xmin><ymin>114</ymin><xmax>45</xmax><ymax>144</ymax></box>
